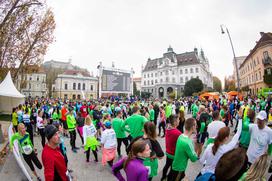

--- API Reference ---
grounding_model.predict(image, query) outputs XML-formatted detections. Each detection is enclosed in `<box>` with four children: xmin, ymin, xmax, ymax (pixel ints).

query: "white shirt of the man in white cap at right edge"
<box><xmin>247</xmin><ymin>124</ymin><xmax>272</xmax><ymax>163</ymax></box>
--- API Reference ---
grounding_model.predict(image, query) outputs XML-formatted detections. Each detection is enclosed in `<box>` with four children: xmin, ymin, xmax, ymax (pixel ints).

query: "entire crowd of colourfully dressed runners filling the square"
<box><xmin>10</xmin><ymin>96</ymin><xmax>272</xmax><ymax>181</ymax></box>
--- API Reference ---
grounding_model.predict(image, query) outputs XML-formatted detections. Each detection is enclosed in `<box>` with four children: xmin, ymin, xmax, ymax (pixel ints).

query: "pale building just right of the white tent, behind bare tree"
<box><xmin>15</xmin><ymin>65</ymin><xmax>48</xmax><ymax>97</ymax></box>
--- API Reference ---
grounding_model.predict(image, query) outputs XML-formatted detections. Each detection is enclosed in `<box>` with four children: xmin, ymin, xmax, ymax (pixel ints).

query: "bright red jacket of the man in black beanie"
<box><xmin>42</xmin><ymin>144</ymin><xmax>67</xmax><ymax>181</ymax></box>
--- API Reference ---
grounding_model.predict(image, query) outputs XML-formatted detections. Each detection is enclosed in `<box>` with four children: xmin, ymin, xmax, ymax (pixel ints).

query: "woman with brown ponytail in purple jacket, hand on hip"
<box><xmin>112</xmin><ymin>139</ymin><xmax>151</xmax><ymax>181</ymax></box>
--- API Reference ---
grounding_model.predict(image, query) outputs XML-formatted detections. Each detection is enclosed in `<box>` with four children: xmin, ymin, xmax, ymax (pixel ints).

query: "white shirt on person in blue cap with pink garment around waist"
<box><xmin>101</xmin><ymin>129</ymin><xmax>117</xmax><ymax>149</ymax></box>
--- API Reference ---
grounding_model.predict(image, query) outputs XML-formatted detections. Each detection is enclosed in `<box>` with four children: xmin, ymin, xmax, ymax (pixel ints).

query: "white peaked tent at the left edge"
<box><xmin>0</xmin><ymin>72</ymin><xmax>25</xmax><ymax>114</ymax></box>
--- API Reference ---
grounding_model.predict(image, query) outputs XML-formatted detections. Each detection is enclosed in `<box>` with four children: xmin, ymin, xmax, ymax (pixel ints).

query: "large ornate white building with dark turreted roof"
<box><xmin>141</xmin><ymin>47</ymin><xmax>213</xmax><ymax>98</ymax></box>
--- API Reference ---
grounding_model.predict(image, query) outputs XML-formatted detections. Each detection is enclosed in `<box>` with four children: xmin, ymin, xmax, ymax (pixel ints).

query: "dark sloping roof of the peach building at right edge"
<box><xmin>239</xmin><ymin>32</ymin><xmax>272</xmax><ymax>68</ymax></box>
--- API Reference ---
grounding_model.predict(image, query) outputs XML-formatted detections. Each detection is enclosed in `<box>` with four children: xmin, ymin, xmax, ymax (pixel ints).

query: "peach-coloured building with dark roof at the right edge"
<box><xmin>239</xmin><ymin>32</ymin><xmax>272</xmax><ymax>94</ymax></box>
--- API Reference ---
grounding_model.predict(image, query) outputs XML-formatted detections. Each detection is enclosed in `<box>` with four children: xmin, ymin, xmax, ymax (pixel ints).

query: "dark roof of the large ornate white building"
<box><xmin>143</xmin><ymin>51</ymin><xmax>200</xmax><ymax>71</ymax></box>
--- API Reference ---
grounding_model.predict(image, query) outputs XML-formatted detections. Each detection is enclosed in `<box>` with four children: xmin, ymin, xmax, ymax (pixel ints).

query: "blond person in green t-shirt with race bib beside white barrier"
<box><xmin>10</xmin><ymin>123</ymin><xmax>42</xmax><ymax>180</ymax></box>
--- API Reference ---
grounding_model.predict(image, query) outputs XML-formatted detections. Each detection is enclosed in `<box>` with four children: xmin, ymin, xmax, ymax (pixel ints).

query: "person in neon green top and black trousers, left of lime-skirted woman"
<box><xmin>66</xmin><ymin>108</ymin><xmax>79</xmax><ymax>153</ymax></box>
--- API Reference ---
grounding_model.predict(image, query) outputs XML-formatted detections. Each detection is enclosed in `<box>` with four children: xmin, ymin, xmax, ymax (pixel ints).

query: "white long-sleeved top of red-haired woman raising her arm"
<box><xmin>199</xmin><ymin>119</ymin><xmax>242</xmax><ymax>175</ymax></box>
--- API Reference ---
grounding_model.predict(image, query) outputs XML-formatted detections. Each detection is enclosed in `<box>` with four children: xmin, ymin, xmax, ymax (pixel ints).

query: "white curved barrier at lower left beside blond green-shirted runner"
<box><xmin>8</xmin><ymin>124</ymin><xmax>32</xmax><ymax>181</ymax></box>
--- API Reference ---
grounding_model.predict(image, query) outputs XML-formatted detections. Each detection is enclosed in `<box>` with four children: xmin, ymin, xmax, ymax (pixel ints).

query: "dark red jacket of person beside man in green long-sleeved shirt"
<box><xmin>165</xmin><ymin>128</ymin><xmax>181</xmax><ymax>155</ymax></box>
